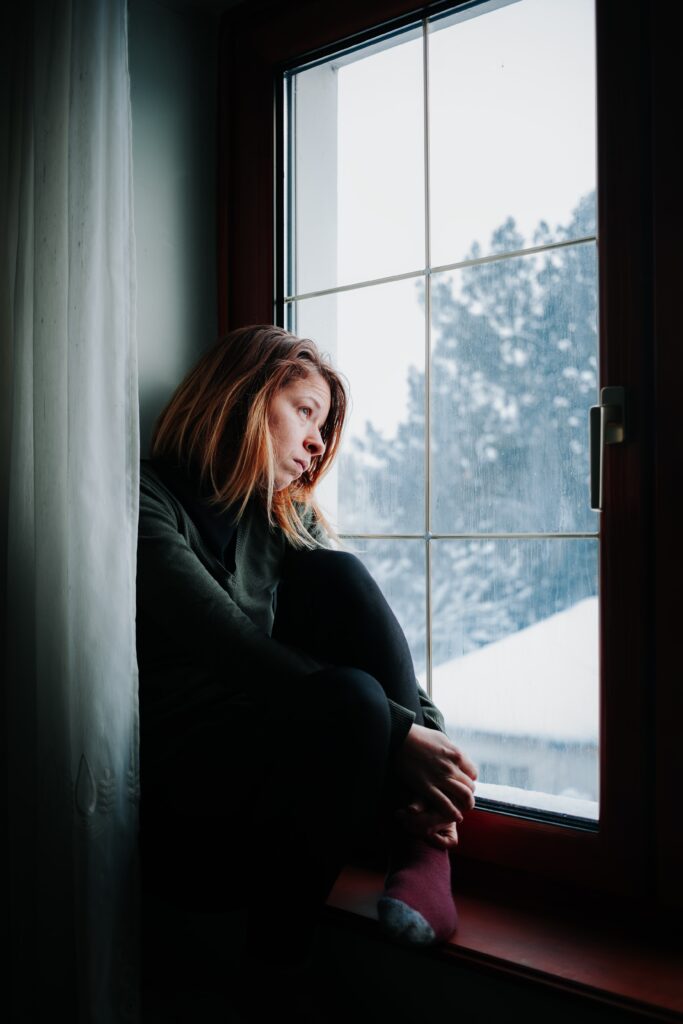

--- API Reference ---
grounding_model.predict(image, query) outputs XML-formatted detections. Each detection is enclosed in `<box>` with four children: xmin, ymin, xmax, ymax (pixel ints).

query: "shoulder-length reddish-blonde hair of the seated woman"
<box><xmin>151</xmin><ymin>325</ymin><xmax>348</xmax><ymax>548</ymax></box>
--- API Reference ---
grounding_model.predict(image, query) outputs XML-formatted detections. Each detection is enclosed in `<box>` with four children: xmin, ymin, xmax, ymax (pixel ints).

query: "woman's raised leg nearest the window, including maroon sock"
<box><xmin>273</xmin><ymin>549</ymin><xmax>457</xmax><ymax>944</ymax></box>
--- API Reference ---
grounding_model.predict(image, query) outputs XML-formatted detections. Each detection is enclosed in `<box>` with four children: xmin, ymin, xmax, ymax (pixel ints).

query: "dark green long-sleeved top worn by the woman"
<box><xmin>136</xmin><ymin>459</ymin><xmax>445</xmax><ymax>770</ymax></box>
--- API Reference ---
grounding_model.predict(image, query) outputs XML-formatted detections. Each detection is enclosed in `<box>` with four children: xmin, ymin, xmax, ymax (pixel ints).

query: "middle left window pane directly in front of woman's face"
<box><xmin>296</xmin><ymin>280</ymin><xmax>425</xmax><ymax>534</ymax></box>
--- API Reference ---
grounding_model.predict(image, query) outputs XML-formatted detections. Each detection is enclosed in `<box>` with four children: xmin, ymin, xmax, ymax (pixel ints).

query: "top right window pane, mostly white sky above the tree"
<box><xmin>429</xmin><ymin>0</ymin><xmax>596</xmax><ymax>266</ymax></box>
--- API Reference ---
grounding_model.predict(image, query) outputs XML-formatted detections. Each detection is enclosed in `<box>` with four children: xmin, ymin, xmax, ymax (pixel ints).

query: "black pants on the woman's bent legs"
<box><xmin>142</xmin><ymin>549</ymin><xmax>424</xmax><ymax>959</ymax></box>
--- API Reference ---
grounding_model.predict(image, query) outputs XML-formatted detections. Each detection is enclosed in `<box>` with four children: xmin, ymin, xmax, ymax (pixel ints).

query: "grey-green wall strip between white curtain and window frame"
<box><xmin>128</xmin><ymin>0</ymin><xmax>218</xmax><ymax>457</ymax></box>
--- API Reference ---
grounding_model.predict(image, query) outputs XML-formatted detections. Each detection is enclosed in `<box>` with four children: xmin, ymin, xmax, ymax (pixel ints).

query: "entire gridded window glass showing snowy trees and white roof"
<box><xmin>278</xmin><ymin>0</ymin><xmax>599</xmax><ymax>824</ymax></box>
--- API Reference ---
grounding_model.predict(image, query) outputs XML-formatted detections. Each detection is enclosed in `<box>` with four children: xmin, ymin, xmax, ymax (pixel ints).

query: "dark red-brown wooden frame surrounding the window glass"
<box><xmin>218</xmin><ymin>0</ymin><xmax>683</xmax><ymax>916</ymax></box>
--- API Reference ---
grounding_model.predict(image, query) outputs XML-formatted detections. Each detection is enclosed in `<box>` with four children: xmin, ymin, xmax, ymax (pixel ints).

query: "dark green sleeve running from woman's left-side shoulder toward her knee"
<box><xmin>137</xmin><ymin>481</ymin><xmax>327</xmax><ymax>686</ymax></box>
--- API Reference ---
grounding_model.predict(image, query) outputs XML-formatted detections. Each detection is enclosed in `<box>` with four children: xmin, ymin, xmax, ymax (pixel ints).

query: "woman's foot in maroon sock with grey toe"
<box><xmin>377</xmin><ymin>831</ymin><xmax>458</xmax><ymax>945</ymax></box>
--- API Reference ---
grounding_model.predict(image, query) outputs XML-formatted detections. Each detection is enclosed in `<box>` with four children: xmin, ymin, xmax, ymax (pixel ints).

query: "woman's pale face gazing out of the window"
<box><xmin>268</xmin><ymin>370</ymin><xmax>332</xmax><ymax>490</ymax></box>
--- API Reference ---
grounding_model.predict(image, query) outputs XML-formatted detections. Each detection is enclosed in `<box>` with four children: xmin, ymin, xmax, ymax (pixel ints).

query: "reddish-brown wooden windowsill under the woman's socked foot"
<box><xmin>328</xmin><ymin>866</ymin><xmax>683</xmax><ymax>1021</ymax></box>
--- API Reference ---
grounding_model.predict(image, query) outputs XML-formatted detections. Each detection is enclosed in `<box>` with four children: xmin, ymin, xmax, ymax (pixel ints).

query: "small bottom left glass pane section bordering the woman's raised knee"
<box><xmin>344</xmin><ymin>538</ymin><xmax>427</xmax><ymax>679</ymax></box>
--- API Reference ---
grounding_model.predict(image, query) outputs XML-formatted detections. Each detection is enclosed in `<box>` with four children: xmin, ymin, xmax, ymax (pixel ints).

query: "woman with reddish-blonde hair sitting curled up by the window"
<box><xmin>137</xmin><ymin>326</ymin><xmax>476</xmax><ymax>1015</ymax></box>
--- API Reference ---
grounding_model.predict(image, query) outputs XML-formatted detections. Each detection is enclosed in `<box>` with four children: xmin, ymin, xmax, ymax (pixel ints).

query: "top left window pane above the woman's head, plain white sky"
<box><xmin>291</xmin><ymin>30</ymin><xmax>425</xmax><ymax>294</ymax></box>
